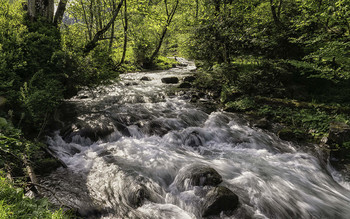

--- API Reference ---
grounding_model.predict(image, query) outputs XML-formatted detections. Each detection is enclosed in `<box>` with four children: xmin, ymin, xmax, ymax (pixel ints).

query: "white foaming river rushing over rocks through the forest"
<box><xmin>41</xmin><ymin>60</ymin><xmax>350</xmax><ymax>219</ymax></box>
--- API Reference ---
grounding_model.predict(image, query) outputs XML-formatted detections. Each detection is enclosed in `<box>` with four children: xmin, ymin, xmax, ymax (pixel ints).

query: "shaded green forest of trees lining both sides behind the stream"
<box><xmin>0</xmin><ymin>0</ymin><xmax>350</xmax><ymax>217</ymax></box>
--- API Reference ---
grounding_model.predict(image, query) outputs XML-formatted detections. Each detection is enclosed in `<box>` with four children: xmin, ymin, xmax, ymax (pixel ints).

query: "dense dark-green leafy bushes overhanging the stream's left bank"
<box><xmin>0</xmin><ymin>0</ymin><xmax>118</xmax><ymax>134</ymax></box>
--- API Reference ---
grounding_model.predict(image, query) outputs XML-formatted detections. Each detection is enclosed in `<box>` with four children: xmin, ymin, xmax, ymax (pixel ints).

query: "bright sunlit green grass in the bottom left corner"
<box><xmin>0</xmin><ymin>172</ymin><xmax>71</xmax><ymax>219</ymax></box>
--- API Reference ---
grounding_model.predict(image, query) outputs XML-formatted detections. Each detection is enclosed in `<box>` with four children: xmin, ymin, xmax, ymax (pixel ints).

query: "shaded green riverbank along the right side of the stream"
<box><xmin>187</xmin><ymin>59</ymin><xmax>350</xmax><ymax>177</ymax></box>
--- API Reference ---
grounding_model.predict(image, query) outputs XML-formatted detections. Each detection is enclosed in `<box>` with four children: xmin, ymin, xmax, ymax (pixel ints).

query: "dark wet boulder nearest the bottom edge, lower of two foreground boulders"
<box><xmin>202</xmin><ymin>186</ymin><xmax>239</xmax><ymax>217</ymax></box>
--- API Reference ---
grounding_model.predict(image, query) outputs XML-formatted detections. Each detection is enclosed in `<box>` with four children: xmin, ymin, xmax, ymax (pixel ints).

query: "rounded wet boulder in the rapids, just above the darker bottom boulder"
<box><xmin>174</xmin><ymin>164</ymin><xmax>222</xmax><ymax>191</ymax></box>
